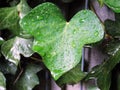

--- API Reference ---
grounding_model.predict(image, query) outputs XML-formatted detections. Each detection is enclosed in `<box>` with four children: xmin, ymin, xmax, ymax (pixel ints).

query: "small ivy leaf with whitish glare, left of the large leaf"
<box><xmin>1</xmin><ymin>36</ymin><xmax>33</xmax><ymax>65</ymax></box>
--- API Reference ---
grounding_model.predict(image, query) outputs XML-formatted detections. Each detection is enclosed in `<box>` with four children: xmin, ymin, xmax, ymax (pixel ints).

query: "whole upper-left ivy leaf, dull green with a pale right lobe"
<box><xmin>0</xmin><ymin>0</ymin><xmax>30</xmax><ymax>35</ymax></box>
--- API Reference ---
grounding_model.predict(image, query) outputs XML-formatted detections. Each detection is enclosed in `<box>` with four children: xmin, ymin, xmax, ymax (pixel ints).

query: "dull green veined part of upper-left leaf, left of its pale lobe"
<box><xmin>0</xmin><ymin>7</ymin><xmax>20</xmax><ymax>35</ymax></box>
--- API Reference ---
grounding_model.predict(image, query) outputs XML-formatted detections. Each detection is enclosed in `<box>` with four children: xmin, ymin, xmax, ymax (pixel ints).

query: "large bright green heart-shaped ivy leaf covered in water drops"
<box><xmin>20</xmin><ymin>2</ymin><xmax>104</xmax><ymax>80</ymax></box>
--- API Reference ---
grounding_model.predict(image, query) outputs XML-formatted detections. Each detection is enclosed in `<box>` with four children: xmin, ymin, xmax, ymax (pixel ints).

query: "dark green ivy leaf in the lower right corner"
<box><xmin>86</xmin><ymin>50</ymin><xmax>120</xmax><ymax>90</ymax></box>
